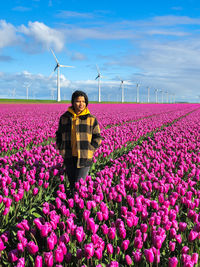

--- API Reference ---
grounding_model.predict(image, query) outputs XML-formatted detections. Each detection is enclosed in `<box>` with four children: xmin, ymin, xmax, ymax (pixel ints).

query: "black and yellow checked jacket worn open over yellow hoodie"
<box><xmin>56</xmin><ymin>111</ymin><xmax>102</xmax><ymax>168</ymax></box>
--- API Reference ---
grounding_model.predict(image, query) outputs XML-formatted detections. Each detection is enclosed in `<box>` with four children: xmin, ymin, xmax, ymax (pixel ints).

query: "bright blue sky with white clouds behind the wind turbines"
<box><xmin>0</xmin><ymin>0</ymin><xmax>200</xmax><ymax>102</ymax></box>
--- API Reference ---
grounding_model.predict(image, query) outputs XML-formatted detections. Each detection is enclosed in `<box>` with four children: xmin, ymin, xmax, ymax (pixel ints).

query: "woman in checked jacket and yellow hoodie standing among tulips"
<box><xmin>56</xmin><ymin>91</ymin><xmax>102</xmax><ymax>190</ymax></box>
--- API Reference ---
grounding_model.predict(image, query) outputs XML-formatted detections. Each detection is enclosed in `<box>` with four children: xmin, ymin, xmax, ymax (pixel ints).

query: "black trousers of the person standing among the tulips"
<box><xmin>65</xmin><ymin>157</ymin><xmax>90</xmax><ymax>190</ymax></box>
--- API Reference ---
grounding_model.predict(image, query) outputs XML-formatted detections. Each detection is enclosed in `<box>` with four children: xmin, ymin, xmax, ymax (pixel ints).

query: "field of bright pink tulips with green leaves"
<box><xmin>0</xmin><ymin>104</ymin><xmax>200</xmax><ymax>267</ymax></box>
